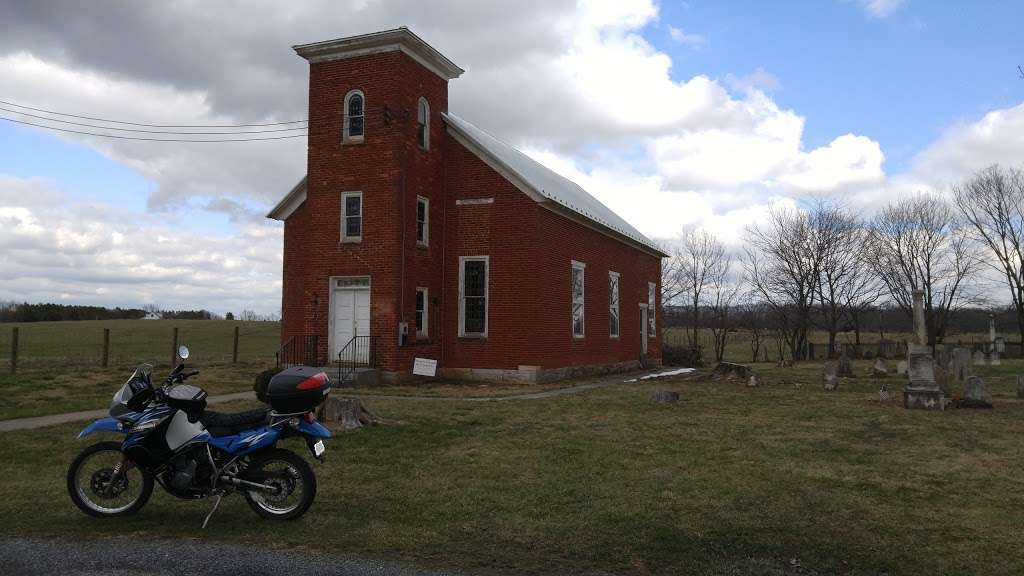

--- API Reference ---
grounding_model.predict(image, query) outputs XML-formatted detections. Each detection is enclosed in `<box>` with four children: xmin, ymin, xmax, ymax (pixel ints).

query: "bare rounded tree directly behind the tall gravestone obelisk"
<box><xmin>865</xmin><ymin>194</ymin><xmax>978</xmax><ymax>346</ymax></box>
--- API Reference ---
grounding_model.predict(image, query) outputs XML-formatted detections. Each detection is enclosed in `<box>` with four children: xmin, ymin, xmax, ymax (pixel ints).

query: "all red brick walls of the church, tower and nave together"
<box><xmin>282</xmin><ymin>47</ymin><xmax>662</xmax><ymax>371</ymax></box>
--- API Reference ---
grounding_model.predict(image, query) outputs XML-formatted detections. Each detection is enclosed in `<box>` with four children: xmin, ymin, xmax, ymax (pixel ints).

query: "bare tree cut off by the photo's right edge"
<box><xmin>953</xmin><ymin>165</ymin><xmax>1024</xmax><ymax>352</ymax></box>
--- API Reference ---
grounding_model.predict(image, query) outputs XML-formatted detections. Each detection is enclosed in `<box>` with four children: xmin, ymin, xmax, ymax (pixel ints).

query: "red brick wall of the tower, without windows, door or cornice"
<box><xmin>282</xmin><ymin>51</ymin><xmax>447</xmax><ymax>366</ymax></box>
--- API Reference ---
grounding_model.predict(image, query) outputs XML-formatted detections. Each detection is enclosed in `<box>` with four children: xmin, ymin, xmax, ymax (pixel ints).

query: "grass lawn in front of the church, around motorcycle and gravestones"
<box><xmin>0</xmin><ymin>361</ymin><xmax>1024</xmax><ymax>575</ymax></box>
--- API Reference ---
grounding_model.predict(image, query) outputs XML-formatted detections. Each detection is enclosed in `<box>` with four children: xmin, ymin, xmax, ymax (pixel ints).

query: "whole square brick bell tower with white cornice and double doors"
<box><xmin>282</xmin><ymin>28</ymin><xmax>463</xmax><ymax>378</ymax></box>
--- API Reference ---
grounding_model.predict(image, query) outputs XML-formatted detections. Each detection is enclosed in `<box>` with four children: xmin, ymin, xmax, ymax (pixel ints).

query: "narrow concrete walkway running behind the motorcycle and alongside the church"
<box><xmin>0</xmin><ymin>370</ymin><xmax>692</xmax><ymax>433</ymax></box>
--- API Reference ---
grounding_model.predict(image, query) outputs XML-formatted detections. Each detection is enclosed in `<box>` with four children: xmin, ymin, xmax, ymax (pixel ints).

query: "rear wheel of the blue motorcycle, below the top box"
<box><xmin>245</xmin><ymin>448</ymin><xmax>316</xmax><ymax>520</ymax></box>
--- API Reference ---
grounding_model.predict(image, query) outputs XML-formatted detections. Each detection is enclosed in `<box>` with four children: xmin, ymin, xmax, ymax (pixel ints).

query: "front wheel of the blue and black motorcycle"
<box><xmin>68</xmin><ymin>442</ymin><xmax>153</xmax><ymax>518</ymax></box>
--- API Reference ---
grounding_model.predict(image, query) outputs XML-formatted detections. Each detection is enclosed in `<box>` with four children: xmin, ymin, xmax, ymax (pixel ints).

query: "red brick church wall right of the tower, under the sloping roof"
<box><xmin>443</xmin><ymin>141</ymin><xmax>662</xmax><ymax>370</ymax></box>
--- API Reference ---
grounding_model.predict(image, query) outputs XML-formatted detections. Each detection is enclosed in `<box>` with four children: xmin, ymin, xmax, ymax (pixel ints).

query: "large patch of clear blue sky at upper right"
<box><xmin>644</xmin><ymin>0</ymin><xmax>1024</xmax><ymax>171</ymax></box>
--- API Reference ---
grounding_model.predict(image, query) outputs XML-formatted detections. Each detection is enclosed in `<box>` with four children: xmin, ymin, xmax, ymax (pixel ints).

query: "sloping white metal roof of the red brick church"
<box><xmin>442</xmin><ymin>113</ymin><xmax>665</xmax><ymax>255</ymax></box>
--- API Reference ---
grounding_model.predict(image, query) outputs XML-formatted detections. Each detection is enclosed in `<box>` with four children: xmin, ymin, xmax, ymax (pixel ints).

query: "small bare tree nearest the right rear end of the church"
<box><xmin>672</xmin><ymin>230</ymin><xmax>732</xmax><ymax>346</ymax></box>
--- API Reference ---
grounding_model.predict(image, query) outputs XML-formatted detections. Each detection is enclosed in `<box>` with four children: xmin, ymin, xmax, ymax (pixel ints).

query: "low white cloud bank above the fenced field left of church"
<box><xmin>0</xmin><ymin>175</ymin><xmax>281</xmax><ymax>313</ymax></box>
